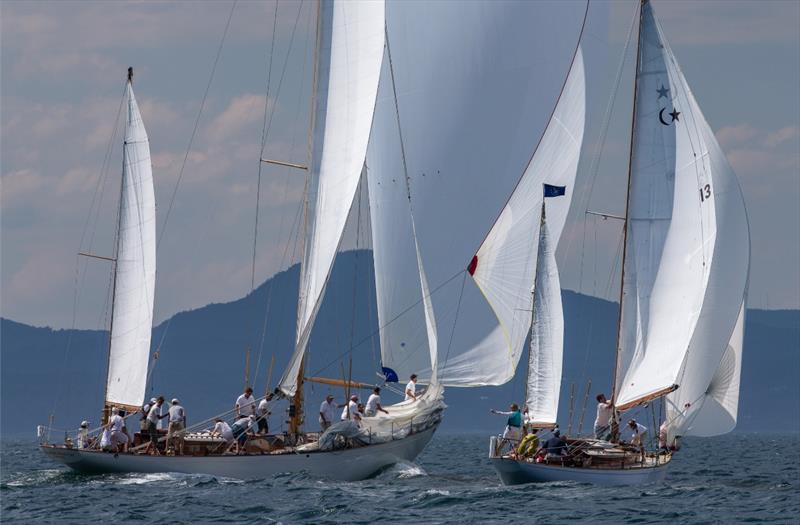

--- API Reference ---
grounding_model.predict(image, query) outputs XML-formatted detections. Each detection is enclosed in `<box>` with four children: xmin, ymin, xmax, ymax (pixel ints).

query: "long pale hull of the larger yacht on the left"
<box><xmin>41</xmin><ymin>425</ymin><xmax>438</xmax><ymax>481</ymax></box>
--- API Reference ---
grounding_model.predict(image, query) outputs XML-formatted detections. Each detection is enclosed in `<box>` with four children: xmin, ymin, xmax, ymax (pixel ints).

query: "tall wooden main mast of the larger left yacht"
<box><xmin>289</xmin><ymin>0</ymin><xmax>322</xmax><ymax>437</ymax></box>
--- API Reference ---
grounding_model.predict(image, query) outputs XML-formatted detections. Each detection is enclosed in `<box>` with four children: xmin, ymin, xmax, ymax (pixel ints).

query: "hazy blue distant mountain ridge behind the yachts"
<box><xmin>0</xmin><ymin>251</ymin><xmax>800</xmax><ymax>437</ymax></box>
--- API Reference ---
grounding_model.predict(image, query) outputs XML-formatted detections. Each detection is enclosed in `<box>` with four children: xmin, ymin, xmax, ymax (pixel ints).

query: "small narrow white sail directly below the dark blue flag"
<box><xmin>525</xmin><ymin>210</ymin><xmax>564</xmax><ymax>424</ymax></box>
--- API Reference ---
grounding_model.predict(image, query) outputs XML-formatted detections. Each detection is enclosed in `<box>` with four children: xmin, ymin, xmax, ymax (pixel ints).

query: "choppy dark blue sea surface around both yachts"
<box><xmin>0</xmin><ymin>434</ymin><xmax>800</xmax><ymax>525</ymax></box>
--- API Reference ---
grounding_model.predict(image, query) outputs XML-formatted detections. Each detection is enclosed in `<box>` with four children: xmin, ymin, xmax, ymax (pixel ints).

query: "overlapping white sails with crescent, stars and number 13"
<box><xmin>615</xmin><ymin>2</ymin><xmax>749</xmax><ymax>409</ymax></box>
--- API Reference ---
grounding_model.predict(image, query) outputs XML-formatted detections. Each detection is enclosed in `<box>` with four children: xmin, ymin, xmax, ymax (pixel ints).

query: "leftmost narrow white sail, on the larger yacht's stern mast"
<box><xmin>106</xmin><ymin>82</ymin><xmax>156</xmax><ymax>406</ymax></box>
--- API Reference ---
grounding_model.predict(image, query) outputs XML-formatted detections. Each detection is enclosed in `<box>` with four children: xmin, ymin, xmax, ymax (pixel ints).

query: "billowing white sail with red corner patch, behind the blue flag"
<box><xmin>460</xmin><ymin>48</ymin><xmax>586</xmax><ymax>386</ymax></box>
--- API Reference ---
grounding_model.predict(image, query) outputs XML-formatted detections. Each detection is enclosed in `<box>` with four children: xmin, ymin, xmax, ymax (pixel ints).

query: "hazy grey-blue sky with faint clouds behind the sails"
<box><xmin>0</xmin><ymin>1</ymin><xmax>800</xmax><ymax>328</ymax></box>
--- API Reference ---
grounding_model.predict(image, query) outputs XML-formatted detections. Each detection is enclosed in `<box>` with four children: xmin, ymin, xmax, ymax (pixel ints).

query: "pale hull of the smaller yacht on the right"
<box><xmin>491</xmin><ymin>458</ymin><xmax>669</xmax><ymax>485</ymax></box>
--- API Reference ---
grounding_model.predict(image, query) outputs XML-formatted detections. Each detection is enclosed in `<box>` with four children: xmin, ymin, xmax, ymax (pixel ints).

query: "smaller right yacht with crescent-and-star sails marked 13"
<box><xmin>490</xmin><ymin>0</ymin><xmax>750</xmax><ymax>485</ymax></box>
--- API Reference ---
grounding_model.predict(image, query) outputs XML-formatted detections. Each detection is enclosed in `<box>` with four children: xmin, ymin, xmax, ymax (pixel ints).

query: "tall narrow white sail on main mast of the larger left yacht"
<box><xmin>281</xmin><ymin>1</ymin><xmax>385</xmax><ymax>395</ymax></box>
